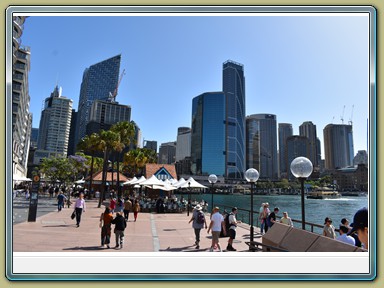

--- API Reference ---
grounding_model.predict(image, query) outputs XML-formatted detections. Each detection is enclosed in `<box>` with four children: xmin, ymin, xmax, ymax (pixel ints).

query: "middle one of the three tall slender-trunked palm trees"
<box><xmin>98</xmin><ymin>130</ymin><xmax>119</xmax><ymax>208</ymax></box>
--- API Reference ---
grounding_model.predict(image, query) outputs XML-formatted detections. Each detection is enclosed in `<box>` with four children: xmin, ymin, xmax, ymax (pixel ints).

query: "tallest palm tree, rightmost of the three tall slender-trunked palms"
<box><xmin>111</xmin><ymin>121</ymin><xmax>135</xmax><ymax>197</ymax></box>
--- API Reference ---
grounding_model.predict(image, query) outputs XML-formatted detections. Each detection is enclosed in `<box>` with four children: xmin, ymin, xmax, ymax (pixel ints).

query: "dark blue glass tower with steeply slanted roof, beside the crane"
<box><xmin>75</xmin><ymin>55</ymin><xmax>121</xmax><ymax>145</ymax></box>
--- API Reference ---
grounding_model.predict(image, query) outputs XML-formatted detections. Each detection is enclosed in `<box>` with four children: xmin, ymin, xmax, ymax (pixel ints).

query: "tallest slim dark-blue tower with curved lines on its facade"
<box><xmin>223</xmin><ymin>60</ymin><xmax>245</xmax><ymax>179</ymax></box>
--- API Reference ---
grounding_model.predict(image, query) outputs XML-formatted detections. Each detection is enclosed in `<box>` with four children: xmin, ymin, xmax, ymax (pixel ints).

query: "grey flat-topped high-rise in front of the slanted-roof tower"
<box><xmin>86</xmin><ymin>100</ymin><xmax>131</xmax><ymax>135</ymax></box>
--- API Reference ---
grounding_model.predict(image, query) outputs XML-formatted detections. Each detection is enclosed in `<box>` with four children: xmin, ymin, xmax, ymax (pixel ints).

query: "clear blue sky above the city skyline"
<box><xmin>22</xmin><ymin>15</ymin><xmax>369</xmax><ymax>155</ymax></box>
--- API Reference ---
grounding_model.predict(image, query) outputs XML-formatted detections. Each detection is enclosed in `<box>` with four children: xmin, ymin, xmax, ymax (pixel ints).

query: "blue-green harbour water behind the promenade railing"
<box><xmin>186</xmin><ymin>193</ymin><xmax>369</xmax><ymax>233</ymax></box>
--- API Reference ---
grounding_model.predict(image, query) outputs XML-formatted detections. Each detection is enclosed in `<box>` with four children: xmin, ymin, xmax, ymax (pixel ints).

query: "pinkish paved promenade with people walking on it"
<box><xmin>13</xmin><ymin>200</ymin><xmax>261</xmax><ymax>253</ymax></box>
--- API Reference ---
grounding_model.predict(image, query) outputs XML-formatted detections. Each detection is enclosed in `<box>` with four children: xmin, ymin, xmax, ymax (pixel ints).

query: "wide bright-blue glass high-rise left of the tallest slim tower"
<box><xmin>191</xmin><ymin>92</ymin><xmax>226</xmax><ymax>176</ymax></box>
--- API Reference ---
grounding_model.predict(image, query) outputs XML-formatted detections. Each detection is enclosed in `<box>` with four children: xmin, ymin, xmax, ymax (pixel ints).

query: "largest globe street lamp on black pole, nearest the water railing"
<box><xmin>291</xmin><ymin>157</ymin><xmax>313</xmax><ymax>230</ymax></box>
